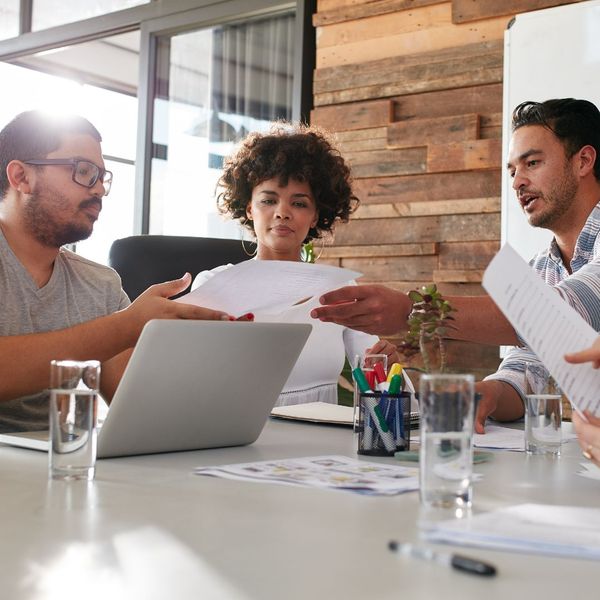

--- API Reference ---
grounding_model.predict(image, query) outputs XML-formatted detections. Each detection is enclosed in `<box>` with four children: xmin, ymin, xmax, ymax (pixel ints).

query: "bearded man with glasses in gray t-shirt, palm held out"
<box><xmin>0</xmin><ymin>111</ymin><xmax>229</xmax><ymax>432</ymax></box>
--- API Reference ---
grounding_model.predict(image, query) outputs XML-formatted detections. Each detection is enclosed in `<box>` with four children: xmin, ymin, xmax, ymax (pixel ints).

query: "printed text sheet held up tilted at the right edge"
<box><xmin>483</xmin><ymin>244</ymin><xmax>600</xmax><ymax>415</ymax></box>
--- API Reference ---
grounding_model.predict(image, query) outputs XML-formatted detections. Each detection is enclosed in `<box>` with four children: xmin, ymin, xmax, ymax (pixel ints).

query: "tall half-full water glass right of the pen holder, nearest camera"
<box><xmin>419</xmin><ymin>374</ymin><xmax>475</xmax><ymax>509</ymax></box>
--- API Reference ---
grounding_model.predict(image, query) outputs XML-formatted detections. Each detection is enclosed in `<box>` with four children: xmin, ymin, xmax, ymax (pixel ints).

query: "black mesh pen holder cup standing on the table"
<box><xmin>357</xmin><ymin>392</ymin><xmax>410</xmax><ymax>456</ymax></box>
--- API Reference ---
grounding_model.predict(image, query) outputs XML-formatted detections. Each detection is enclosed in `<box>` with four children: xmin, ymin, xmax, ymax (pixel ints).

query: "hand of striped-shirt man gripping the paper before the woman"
<box><xmin>310</xmin><ymin>285</ymin><xmax>412</xmax><ymax>335</ymax></box>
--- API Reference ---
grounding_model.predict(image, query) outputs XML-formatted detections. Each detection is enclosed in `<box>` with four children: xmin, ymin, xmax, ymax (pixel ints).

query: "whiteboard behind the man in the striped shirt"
<box><xmin>501</xmin><ymin>0</ymin><xmax>600</xmax><ymax>260</ymax></box>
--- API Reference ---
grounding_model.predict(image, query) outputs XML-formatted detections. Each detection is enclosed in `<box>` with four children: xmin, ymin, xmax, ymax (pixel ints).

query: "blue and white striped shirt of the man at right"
<box><xmin>485</xmin><ymin>202</ymin><xmax>600</xmax><ymax>399</ymax></box>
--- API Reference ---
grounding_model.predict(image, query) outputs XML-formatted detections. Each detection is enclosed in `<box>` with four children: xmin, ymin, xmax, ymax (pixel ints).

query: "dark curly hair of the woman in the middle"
<box><xmin>217</xmin><ymin>122</ymin><xmax>359</xmax><ymax>242</ymax></box>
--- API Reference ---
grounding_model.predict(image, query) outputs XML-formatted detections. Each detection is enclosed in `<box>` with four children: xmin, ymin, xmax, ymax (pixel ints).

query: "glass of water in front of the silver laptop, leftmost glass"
<box><xmin>49</xmin><ymin>360</ymin><xmax>100</xmax><ymax>480</ymax></box>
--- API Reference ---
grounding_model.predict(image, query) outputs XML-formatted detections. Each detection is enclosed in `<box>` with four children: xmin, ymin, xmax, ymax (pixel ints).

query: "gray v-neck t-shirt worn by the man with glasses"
<box><xmin>0</xmin><ymin>230</ymin><xmax>130</xmax><ymax>433</ymax></box>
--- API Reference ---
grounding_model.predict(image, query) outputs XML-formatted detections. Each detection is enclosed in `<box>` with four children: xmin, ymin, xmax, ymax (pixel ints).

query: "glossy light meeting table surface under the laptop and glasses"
<box><xmin>0</xmin><ymin>419</ymin><xmax>600</xmax><ymax>600</ymax></box>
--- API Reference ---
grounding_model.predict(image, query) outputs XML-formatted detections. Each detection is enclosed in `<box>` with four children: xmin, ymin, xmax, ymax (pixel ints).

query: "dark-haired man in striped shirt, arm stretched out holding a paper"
<box><xmin>312</xmin><ymin>98</ymin><xmax>600</xmax><ymax>433</ymax></box>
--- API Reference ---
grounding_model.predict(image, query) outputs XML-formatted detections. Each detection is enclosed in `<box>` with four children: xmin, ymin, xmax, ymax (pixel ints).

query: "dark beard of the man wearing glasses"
<box><xmin>24</xmin><ymin>190</ymin><xmax>100</xmax><ymax>248</ymax></box>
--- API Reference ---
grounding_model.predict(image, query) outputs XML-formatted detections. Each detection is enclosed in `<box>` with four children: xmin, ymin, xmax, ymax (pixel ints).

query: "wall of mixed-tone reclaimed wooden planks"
<box><xmin>311</xmin><ymin>0</ymin><xmax>584</xmax><ymax>377</ymax></box>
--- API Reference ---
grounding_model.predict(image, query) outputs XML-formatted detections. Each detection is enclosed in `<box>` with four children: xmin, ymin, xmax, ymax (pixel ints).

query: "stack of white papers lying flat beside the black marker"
<box><xmin>424</xmin><ymin>504</ymin><xmax>600</xmax><ymax>560</ymax></box>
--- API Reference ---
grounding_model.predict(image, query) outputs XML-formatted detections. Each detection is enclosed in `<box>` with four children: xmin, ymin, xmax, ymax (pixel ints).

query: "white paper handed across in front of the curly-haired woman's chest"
<box><xmin>178</xmin><ymin>260</ymin><xmax>362</xmax><ymax>316</ymax></box>
